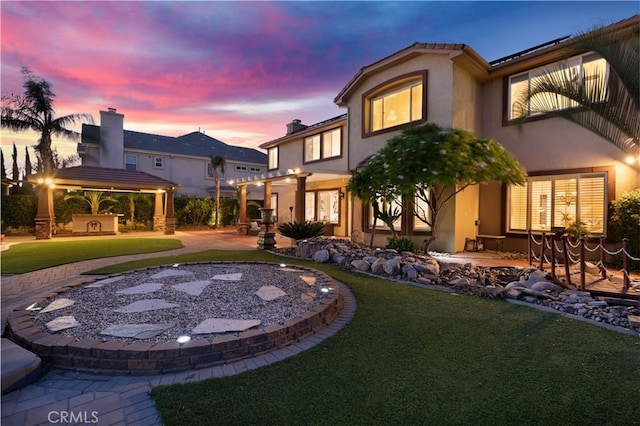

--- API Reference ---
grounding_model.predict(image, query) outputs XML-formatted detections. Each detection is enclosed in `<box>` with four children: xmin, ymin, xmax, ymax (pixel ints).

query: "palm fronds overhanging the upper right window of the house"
<box><xmin>520</xmin><ymin>16</ymin><xmax>640</xmax><ymax>152</ymax></box>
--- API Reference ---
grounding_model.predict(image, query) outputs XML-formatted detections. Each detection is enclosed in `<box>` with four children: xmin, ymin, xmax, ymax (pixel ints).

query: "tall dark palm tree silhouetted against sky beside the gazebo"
<box><xmin>2</xmin><ymin>67</ymin><xmax>93</xmax><ymax>174</ymax></box>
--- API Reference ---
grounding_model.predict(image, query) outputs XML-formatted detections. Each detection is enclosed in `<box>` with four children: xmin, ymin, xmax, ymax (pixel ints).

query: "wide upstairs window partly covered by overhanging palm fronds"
<box><xmin>508</xmin><ymin>53</ymin><xmax>608</xmax><ymax>120</ymax></box>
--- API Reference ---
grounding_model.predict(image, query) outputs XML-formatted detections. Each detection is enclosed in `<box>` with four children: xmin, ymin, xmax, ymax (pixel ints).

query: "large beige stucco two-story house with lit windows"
<box><xmin>239</xmin><ymin>16</ymin><xmax>640</xmax><ymax>252</ymax></box>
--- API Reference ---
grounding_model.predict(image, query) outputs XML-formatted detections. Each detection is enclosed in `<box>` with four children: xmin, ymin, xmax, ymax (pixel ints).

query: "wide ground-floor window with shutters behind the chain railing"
<box><xmin>508</xmin><ymin>173</ymin><xmax>607</xmax><ymax>234</ymax></box>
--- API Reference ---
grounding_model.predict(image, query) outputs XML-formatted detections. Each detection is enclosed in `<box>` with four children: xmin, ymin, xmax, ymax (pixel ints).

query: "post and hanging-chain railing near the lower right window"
<box><xmin>528</xmin><ymin>231</ymin><xmax>640</xmax><ymax>293</ymax></box>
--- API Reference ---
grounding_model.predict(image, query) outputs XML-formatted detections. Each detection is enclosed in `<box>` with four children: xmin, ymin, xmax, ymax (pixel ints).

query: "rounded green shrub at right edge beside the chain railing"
<box><xmin>609</xmin><ymin>188</ymin><xmax>640</xmax><ymax>271</ymax></box>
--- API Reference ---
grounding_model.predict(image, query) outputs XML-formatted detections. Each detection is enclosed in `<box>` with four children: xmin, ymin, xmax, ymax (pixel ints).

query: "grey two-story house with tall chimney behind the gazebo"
<box><xmin>78</xmin><ymin>108</ymin><xmax>267</xmax><ymax>200</ymax></box>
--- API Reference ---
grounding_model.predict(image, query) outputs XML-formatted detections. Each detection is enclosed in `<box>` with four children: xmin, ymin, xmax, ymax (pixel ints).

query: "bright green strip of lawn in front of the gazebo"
<box><xmin>0</xmin><ymin>238</ymin><xmax>184</xmax><ymax>274</ymax></box>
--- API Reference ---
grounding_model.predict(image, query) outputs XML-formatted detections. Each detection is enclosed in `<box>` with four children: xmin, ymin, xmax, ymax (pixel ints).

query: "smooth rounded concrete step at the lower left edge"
<box><xmin>0</xmin><ymin>338</ymin><xmax>43</xmax><ymax>395</ymax></box>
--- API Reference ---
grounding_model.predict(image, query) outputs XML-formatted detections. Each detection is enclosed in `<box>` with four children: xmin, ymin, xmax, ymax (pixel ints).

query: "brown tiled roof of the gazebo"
<box><xmin>29</xmin><ymin>166</ymin><xmax>180</xmax><ymax>192</ymax></box>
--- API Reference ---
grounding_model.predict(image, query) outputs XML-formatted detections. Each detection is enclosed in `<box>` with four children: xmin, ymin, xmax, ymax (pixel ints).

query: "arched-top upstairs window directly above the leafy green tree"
<box><xmin>363</xmin><ymin>72</ymin><xmax>426</xmax><ymax>133</ymax></box>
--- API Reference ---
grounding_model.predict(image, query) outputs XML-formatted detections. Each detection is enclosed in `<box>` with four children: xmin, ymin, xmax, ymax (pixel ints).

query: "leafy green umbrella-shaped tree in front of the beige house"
<box><xmin>349</xmin><ymin>123</ymin><xmax>524</xmax><ymax>249</ymax></box>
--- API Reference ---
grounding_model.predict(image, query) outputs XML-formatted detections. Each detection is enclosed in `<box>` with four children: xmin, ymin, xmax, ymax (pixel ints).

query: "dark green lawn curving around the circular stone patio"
<box><xmin>96</xmin><ymin>251</ymin><xmax>640</xmax><ymax>425</ymax></box>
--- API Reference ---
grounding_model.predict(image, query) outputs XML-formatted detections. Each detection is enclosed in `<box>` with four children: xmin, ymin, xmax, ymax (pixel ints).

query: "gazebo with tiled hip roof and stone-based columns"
<box><xmin>28</xmin><ymin>166</ymin><xmax>180</xmax><ymax>240</ymax></box>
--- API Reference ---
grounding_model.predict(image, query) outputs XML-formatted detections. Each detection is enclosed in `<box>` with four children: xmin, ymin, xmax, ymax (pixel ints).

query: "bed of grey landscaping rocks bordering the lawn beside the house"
<box><xmin>275</xmin><ymin>237</ymin><xmax>640</xmax><ymax>336</ymax></box>
